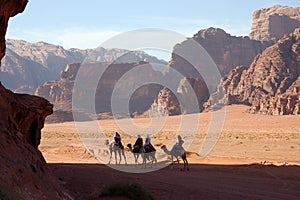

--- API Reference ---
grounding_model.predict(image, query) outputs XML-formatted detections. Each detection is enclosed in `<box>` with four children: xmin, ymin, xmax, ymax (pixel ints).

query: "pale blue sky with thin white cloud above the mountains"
<box><xmin>7</xmin><ymin>0</ymin><xmax>300</xmax><ymax>48</ymax></box>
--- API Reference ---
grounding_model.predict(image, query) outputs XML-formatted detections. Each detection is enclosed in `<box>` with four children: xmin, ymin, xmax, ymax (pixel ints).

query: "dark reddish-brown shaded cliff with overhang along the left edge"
<box><xmin>0</xmin><ymin>0</ymin><xmax>70</xmax><ymax>199</ymax></box>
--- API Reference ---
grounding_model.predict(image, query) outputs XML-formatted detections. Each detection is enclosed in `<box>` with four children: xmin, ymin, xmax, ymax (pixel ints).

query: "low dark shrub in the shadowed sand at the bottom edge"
<box><xmin>99</xmin><ymin>183</ymin><xmax>154</xmax><ymax>200</ymax></box>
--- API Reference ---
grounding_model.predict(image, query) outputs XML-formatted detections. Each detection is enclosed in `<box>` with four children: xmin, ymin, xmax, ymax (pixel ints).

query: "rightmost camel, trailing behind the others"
<box><xmin>161</xmin><ymin>143</ymin><xmax>189</xmax><ymax>171</ymax></box>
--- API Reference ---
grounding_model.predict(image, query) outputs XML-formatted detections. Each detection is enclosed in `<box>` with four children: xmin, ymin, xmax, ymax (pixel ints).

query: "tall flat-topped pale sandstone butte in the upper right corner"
<box><xmin>249</xmin><ymin>5</ymin><xmax>300</xmax><ymax>41</ymax></box>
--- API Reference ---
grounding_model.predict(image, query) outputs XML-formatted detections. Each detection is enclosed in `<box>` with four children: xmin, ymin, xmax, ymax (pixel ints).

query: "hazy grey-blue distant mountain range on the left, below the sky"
<box><xmin>0</xmin><ymin>39</ymin><xmax>166</xmax><ymax>93</ymax></box>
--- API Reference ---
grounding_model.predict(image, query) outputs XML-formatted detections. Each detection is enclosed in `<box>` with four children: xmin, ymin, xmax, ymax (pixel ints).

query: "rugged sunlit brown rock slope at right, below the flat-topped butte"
<box><xmin>207</xmin><ymin>29</ymin><xmax>300</xmax><ymax>115</ymax></box>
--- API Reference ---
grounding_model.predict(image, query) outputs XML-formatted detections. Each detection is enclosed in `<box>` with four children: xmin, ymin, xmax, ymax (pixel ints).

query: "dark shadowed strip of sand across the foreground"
<box><xmin>49</xmin><ymin>164</ymin><xmax>300</xmax><ymax>200</ymax></box>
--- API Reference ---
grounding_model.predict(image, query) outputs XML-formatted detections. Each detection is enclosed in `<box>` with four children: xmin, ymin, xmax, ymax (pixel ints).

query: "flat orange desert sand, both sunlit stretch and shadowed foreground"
<box><xmin>39</xmin><ymin>105</ymin><xmax>300</xmax><ymax>199</ymax></box>
